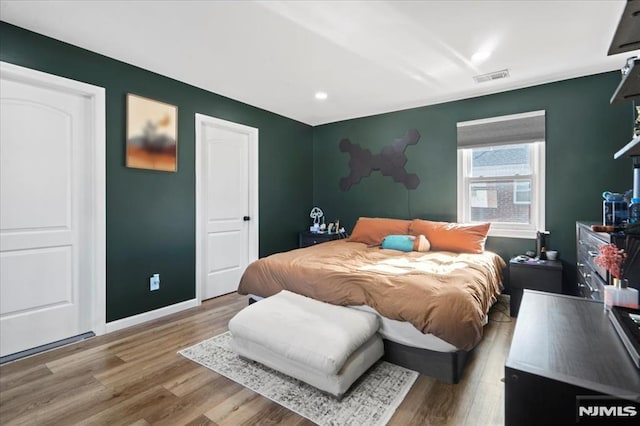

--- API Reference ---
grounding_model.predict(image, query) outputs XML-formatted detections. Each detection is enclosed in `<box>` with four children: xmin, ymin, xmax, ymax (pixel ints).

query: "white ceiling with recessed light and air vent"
<box><xmin>0</xmin><ymin>0</ymin><xmax>640</xmax><ymax>125</ymax></box>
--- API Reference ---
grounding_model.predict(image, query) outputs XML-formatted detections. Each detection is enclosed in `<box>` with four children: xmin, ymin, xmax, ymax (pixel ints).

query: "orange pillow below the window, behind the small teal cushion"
<box><xmin>409</xmin><ymin>219</ymin><xmax>491</xmax><ymax>253</ymax></box>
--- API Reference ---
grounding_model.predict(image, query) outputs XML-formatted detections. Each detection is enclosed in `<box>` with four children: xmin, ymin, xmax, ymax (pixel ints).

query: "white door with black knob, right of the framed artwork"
<box><xmin>196</xmin><ymin>114</ymin><xmax>258</xmax><ymax>300</ymax></box>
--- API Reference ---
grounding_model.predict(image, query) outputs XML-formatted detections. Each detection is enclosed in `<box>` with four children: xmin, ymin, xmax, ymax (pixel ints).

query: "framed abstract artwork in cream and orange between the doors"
<box><xmin>126</xmin><ymin>93</ymin><xmax>178</xmax><ymax>172</ymax></box>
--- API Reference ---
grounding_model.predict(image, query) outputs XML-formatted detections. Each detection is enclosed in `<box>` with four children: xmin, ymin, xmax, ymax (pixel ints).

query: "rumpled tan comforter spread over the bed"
<box><xmin>238</xmin><ymin>240</ymin><xmax>505</xmax><ymax>350</ymax></box>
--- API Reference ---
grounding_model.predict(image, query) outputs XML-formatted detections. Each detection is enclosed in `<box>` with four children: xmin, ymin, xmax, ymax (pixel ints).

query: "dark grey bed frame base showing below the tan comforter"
<box><xmin>249</xmin><ymin>297</ymin><xmax>473</xmax><ymax>384</ymax></box>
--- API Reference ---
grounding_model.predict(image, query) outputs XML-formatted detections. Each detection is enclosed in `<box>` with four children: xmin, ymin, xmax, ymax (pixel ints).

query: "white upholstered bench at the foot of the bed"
<box><xmin>229</xmin><ymin>290</ymin><xmax>384</xmax><ymax>398</ymax></box>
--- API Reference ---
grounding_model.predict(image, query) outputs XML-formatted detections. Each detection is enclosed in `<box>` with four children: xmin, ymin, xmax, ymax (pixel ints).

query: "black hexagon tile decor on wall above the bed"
<box><xmin>339</xmin><ymin>129</ymin><xmax>420</xmax><ymax>191</ymax></box>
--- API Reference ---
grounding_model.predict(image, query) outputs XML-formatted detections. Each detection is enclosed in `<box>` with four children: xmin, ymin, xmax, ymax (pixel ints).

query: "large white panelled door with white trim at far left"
<box><xmin>0</xmin><ymin>64</ymin><xmax>104</xmax><ymax>356</ymax></box>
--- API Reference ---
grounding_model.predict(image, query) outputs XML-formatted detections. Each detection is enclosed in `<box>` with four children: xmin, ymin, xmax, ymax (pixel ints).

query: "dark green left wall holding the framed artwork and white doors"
<box><xmin>0</xmin><ymin>22</ymin><xmax>313</xmax><ymax>321</ymax></box>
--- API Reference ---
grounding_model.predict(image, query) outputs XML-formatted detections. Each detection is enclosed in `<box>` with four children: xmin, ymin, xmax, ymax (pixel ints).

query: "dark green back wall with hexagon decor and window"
<box><xmin>313</xmin><ymin>72</ymin><xmax>633</xmax><ymax>291</ymax></box>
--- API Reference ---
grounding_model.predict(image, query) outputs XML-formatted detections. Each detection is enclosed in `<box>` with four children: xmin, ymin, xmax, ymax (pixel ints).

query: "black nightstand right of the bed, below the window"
<box><xmin>509</xmin><ymin>258</ymin><xmax>562</xmax><ymax>317</ymax></box>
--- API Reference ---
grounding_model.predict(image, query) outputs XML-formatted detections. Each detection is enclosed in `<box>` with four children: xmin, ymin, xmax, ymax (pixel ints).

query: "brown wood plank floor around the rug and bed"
<box><xmin>0</xmin><ymin>293</ymin><xmax>515</xmax><ymax>426</ymax></box>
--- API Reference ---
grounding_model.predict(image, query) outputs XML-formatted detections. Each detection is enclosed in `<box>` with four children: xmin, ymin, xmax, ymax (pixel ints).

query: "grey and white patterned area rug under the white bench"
<box><xmin>178</xmin><ymin>332</ymin><xmax>418</xmax><ymax>426</ymax></box>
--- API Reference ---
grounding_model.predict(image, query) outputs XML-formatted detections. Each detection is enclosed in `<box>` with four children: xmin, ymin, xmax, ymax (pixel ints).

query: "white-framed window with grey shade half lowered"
<box><xmin>458</xmin><ymin>111</ymin><xmax>545</xmax><ymax>238</ymax></box>
